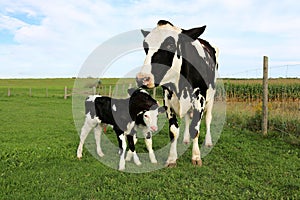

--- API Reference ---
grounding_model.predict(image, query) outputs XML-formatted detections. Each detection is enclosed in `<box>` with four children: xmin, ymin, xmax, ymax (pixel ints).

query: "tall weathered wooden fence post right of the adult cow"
<box><xmin>262</xmin><ymin>56</ymin><xmax>268</xmax><ymax>136</ymax></box>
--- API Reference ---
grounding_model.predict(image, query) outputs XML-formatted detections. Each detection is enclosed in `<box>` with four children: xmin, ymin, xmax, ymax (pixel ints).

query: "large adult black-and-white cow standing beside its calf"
<box><xmin>136</xmin><ymin>20</ymin><xmax>218</xmax><ymax>166</ymax></box>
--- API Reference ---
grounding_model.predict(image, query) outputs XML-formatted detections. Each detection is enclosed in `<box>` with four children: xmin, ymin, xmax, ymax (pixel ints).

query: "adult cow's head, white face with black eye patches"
<box><xmin>136</xmin><ymin>20</ymin><xmax>205</xmax><ymax>88</ymax></box>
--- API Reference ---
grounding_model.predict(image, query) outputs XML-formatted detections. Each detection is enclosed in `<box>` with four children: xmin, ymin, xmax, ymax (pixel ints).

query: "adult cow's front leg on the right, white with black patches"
<box><xmin>190</xmin><ymin>90</ymin><xmax>205</xmax><ymax>166</ymax></box>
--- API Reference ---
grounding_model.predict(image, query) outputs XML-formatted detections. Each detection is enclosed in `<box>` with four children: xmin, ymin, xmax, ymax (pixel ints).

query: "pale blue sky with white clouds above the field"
<box><xmin>0</xmin><ymin>0</ymin><xmax>300</xmax><ymax>78</ymax></box>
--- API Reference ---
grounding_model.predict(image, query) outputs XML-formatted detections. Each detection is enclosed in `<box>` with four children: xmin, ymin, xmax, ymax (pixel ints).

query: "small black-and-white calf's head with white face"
<box><xmin>128</xmin><ymin>88</ymin><xmax>165</xmax><ymax>132</ymax></box>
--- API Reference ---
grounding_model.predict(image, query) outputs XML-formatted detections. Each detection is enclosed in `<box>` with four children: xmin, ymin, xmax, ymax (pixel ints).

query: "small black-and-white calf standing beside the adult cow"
<box><xmin>77</xmin><ymin>89</ymin><xmax>164</xmax><ymax>170</ymax></box>
